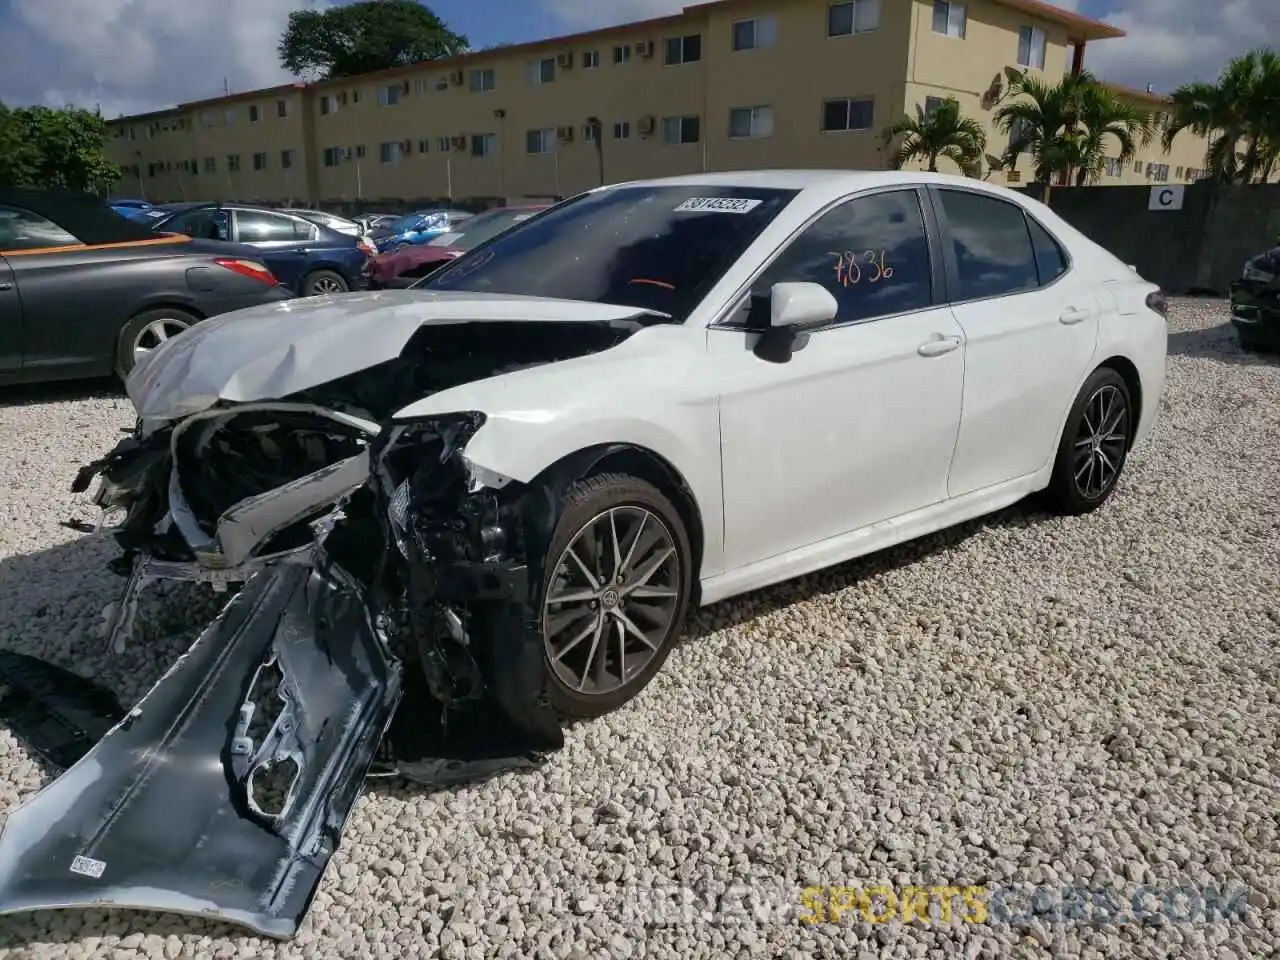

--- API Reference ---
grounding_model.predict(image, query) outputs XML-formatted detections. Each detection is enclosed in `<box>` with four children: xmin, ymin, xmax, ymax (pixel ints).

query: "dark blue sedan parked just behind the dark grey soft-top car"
<box><xmin>152</xmin><ymin>204</ymin><xmax>374</xmax><ymax>297</ymax></box>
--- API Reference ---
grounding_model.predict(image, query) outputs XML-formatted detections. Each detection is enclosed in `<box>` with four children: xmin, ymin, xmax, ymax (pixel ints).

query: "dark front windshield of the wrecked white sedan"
<box><xmin>422</xmin><ymin>184</ymin><xmax>797</xmax><ymax>321</ymax></box>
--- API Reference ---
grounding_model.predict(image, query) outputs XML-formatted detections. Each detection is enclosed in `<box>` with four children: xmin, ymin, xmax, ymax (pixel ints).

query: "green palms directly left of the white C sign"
<box><xmin>995</xmin><ymin>72</ymin><xmax>1155</xmax><ymax>192</ymax></box>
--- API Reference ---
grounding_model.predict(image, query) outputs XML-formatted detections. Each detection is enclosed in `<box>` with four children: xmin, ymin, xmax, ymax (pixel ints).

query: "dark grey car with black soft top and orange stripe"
<box><xmin>0</xmin><ymin>188</ymin><xmax>292</xmax><ymax>384</ymax></box>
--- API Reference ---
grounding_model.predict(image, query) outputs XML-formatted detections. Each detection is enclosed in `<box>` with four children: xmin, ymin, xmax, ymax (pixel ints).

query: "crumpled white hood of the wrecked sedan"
<box><xmin>127</xmin><ymin>289</ymin><xmax>646</xmax><ymax>420</ymax></box>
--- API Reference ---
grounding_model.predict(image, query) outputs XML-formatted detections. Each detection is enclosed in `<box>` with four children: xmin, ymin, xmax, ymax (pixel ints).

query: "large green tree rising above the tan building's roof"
<box><xmin>278</xmin><ymin>0</ymin><xmax>467</xmax><ymax>79</ymax></box>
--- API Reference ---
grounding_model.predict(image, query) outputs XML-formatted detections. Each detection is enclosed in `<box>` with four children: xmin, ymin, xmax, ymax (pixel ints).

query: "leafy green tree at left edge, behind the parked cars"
<box><xmin>0</xmin><ymin>105</ymin><xmax>120</xmax><ymax>192</ymax></box>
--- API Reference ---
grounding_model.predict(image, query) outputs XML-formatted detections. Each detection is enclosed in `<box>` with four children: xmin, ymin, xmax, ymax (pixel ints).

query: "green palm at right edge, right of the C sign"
<box><xmin>1164</xmin><ymin>49</ymin><xmax>1280</xmax><ymax>183</ymax></box>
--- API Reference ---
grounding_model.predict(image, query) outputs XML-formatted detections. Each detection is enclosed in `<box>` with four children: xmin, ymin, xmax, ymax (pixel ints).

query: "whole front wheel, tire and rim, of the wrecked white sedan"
<box><xmin>538</xmin><ymin>474</ymin><xmax>694</xmax><ymax>718</ymax></box>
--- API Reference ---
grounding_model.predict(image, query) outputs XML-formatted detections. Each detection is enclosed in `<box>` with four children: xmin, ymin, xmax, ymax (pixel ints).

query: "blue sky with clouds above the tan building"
<box><xmin>0</xmin><ymin>0</ymin><xmax>1280</xmax><ymax>116</ymax></box>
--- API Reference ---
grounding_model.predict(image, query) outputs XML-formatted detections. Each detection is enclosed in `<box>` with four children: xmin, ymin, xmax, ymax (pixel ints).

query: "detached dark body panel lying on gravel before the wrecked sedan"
<box><xmin>0</xmin><ymin>564</ymin><xmax>401</xmax><ymax>937</ymax></box>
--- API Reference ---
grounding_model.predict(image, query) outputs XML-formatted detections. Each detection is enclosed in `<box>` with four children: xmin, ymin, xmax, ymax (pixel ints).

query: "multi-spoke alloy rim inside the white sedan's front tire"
<box><xmin>543</xmin><ymin>506</ymin><xmax>681</xmax><ymax>696</ymax></box>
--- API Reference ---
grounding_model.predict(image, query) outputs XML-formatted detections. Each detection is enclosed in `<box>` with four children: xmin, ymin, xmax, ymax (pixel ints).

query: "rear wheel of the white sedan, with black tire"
<box><xmin>1044</xmin><ymin>366</ymin><xmax>1138</xmax><ymax>516</ymax></box>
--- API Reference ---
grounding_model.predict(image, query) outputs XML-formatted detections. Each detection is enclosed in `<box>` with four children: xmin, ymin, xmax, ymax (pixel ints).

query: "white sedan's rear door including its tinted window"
<box><xmin>934</xmin><ymin>189</ymin><xmax>1102</xmax><ymax>497</ymax></box>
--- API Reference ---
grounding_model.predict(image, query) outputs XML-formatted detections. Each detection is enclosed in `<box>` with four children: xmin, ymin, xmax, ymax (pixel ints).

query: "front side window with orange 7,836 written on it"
<box><xmin>753</xmin><ymin>189</ymin><xmax>933</xmax><ymax>324</ymax></box>
